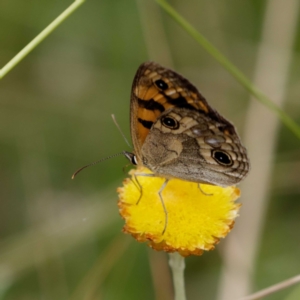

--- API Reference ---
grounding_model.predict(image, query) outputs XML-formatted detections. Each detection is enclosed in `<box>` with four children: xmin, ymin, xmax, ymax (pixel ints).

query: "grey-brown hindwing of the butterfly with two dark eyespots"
<box><xmin>141</xmin><ymin>108</ymin><xmax>249</xmax><ymax>186</ymax></box>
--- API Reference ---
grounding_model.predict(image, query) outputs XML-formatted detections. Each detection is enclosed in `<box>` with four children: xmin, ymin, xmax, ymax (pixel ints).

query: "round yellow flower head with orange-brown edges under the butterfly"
<box><xmin>117</xmin><ymin>167</ymin><xmax>240</xmax><ymax>256</ymax></box>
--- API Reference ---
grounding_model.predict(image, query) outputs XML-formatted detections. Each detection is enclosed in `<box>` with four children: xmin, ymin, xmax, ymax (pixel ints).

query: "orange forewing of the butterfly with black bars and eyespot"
<box><xmin>130</xmin><ymin>62</ymin><xmax>222</xmax><ymax>160</ymax></box>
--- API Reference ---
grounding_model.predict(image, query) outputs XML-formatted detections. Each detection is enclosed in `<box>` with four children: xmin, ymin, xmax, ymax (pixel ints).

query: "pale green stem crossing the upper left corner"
<box><xmin>0</xmin><ymin>0</ymin><xmax>85</xmax><ymax>79</ymax></box>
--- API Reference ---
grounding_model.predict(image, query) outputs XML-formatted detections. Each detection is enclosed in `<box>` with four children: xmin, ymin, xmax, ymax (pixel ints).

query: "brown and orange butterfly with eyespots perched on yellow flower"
<box><xmin>124</xmin><ymin>62</ymin><xmax>249</xmax><ymax>186</ymax></box>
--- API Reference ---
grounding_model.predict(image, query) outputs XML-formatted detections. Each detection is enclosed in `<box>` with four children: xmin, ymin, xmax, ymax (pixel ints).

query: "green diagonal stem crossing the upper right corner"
<box><xmin>155</xmin><ymin>0</ymin><xmax>300</xmax><ymax>139</ymax></box>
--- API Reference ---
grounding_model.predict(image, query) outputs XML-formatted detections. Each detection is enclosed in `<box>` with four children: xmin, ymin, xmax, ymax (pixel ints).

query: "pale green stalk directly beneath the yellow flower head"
<box><xmin>169</xmin><ymin>252</ymin><xmax>186</xmax><ymax>300</ymax></box>
